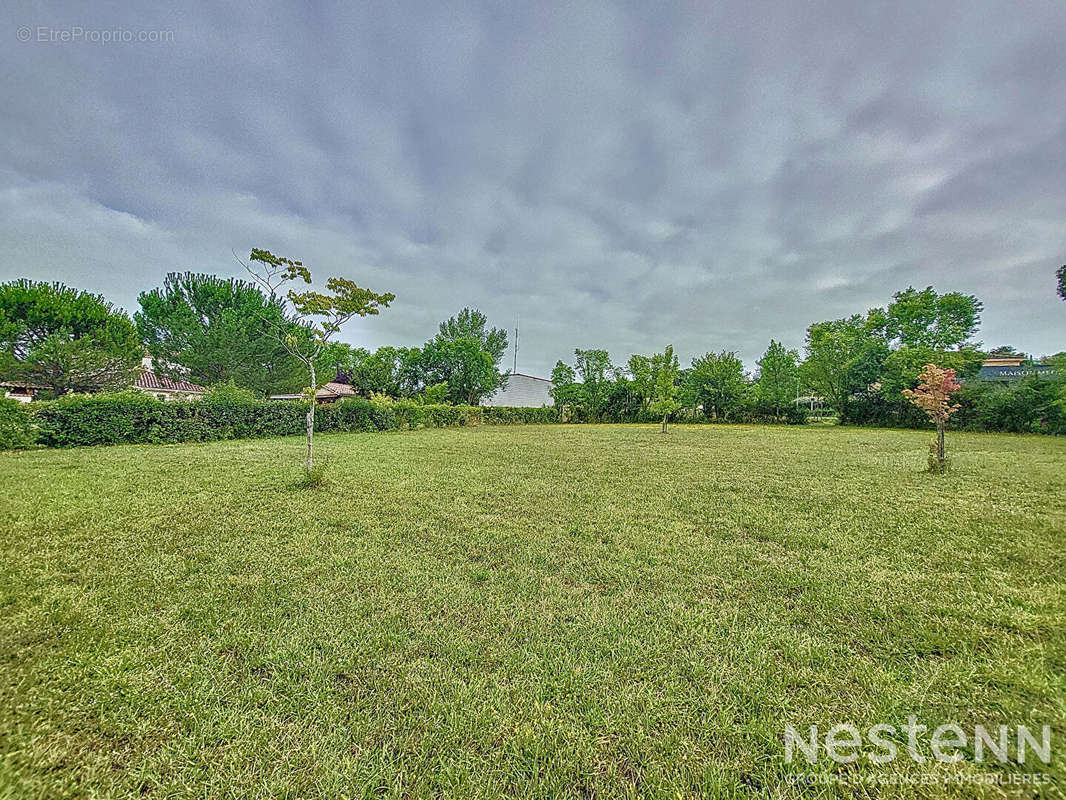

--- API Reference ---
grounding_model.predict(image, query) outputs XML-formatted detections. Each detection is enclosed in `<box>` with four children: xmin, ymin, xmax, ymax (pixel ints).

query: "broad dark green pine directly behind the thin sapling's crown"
<box><xmin>134</xmin><ymin>272</ymin><xmax>304</xmax><ymax>395</ymax></box>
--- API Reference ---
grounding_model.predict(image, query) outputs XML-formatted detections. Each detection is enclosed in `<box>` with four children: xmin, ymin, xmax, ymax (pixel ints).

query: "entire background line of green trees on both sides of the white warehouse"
<box><xmin>0</xmin><ymin>263</ymin><xmax>1066</xmax><ymax>435</ymax></box>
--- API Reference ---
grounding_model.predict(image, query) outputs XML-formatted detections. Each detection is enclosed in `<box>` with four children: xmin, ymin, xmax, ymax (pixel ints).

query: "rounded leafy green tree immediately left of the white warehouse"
<box><xmin>421</xmin><ymin>308</ymin><xmax>507</xmax><ymax>405</ymax></box>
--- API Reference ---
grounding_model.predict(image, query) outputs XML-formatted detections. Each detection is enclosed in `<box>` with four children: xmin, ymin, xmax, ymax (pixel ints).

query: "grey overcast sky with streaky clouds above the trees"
<box><xmin>0</xmin><ymin>0</ymin><xmax>1066</xmax><ymax>375</ymax></box>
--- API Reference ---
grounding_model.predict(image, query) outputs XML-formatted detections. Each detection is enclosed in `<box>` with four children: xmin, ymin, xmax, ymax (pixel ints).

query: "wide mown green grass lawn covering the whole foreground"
<box><xmin>0</xmin><ymin>426</ymin><xmax>1066</xmax><ymax>798</ymax></box>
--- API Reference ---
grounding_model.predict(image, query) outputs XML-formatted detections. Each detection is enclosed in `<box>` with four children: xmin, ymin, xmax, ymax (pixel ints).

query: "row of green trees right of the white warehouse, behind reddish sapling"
<box><xmin>551</xmin><ymin>283</ymin><xmax>1066</xmax><ymax>432</ymax></box>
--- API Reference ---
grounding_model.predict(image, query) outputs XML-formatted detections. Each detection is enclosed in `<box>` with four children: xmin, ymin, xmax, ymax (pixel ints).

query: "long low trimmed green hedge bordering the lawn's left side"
<box><xmin>14</xmin><ymin>391</ymin><xmax>559</xmax><ymax>448</ymax></box>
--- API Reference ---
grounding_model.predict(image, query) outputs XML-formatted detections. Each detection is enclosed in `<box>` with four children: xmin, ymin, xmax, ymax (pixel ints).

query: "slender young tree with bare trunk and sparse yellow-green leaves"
<box><xmin>244</xmin><ymin>247</ymin><xmax>395</xmax><ymax>475</ymax></box>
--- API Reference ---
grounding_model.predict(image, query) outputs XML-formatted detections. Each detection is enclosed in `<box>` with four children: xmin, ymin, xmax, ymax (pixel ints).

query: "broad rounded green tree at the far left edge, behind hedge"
<box><xmin>0</xmin><ymin>278</ymin><xmax>143</xmax><ymax>395</ymax></box>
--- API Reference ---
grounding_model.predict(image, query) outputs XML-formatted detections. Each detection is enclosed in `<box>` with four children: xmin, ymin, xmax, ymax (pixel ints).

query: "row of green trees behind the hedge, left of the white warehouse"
<box><xmin>0</xmin><ymin>275</ymin><xmax>507</xmax><ymax>405</ymax></box>
